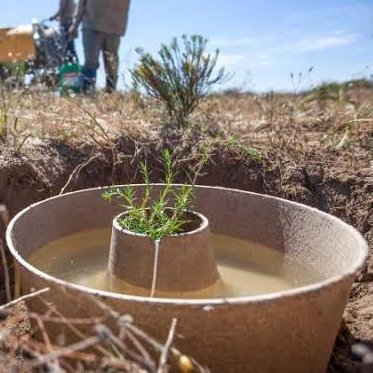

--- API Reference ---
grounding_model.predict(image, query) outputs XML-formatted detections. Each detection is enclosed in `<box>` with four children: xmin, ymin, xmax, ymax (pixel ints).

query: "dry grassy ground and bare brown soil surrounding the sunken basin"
<box><xmin>0</xmin><ymin>82</ymin><xmax>373</xmax><ymax>372</ymax></box>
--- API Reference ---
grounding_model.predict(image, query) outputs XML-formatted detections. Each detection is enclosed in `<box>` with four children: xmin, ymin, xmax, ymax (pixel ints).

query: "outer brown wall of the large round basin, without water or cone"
<box><xmin>7</xmin><ymin>185</ymin><xmax>367</xmax><ymax>373</ymax></box>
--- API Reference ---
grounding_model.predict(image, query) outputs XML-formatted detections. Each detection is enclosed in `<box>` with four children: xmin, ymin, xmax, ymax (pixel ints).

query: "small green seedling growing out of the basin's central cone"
<box><xmin>102</xmin><ymin>150</ymin><xmax>195</xmax><ymax>241</ymax></box>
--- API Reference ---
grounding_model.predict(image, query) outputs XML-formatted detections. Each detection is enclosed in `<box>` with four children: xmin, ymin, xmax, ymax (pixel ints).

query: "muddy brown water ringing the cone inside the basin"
<box><xmin>29</xmin><ymin>229</ymin><xmax>322</xmax><ymax>298</ymax></box>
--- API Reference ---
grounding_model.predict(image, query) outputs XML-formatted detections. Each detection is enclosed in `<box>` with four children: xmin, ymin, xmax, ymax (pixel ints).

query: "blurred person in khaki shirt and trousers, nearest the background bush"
<box><xmin>69</xmin><ymin>0</ymin><xmax>130</xmax><ymax>93</ymax></box>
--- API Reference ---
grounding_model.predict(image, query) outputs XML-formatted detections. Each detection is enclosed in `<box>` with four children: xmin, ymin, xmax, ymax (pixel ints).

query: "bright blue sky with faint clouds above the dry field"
<box><xmin>0</xmin><ymin>0</ymin><xmax>373</xmax><ymax>91</ymax></box>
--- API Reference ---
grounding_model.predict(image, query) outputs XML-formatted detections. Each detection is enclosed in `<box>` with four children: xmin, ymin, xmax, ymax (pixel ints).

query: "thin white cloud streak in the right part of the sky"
<box><xmin>294</xmin><ymin>32</ymin><xmax>359</xmax><ymax>52</ymax></box>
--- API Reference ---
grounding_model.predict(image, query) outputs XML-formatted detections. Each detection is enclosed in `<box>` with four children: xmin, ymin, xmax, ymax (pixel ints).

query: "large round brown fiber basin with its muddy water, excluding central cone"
<box><xmin>7</xmin><ymin>184</ymin><xmax>367</xmax><ymax>373</ymax></box>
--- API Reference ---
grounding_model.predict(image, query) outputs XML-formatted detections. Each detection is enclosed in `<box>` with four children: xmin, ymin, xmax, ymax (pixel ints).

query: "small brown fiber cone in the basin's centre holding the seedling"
<box><xmin>108</xmin><ymin>212</ymin><xmax>219</xmax><ymax>292</ymax></box>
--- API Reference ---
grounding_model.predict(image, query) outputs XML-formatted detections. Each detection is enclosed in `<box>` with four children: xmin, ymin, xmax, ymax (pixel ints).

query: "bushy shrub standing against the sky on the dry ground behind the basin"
<box><xmin>130</xmin><ymin>35</ymin><xmax>226</xmax><ymax>127</ymax></box>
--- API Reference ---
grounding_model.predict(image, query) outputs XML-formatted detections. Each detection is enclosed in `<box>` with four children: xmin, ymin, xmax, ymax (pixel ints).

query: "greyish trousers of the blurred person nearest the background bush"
<box><xmin>83</xmin><ymin>30</ymin><xmax>121</xmax><ymax>92</ymax></box>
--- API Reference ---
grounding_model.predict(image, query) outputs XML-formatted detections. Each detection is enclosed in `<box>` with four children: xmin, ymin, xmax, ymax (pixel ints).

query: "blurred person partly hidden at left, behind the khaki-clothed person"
<box><xmin>49</xmin><ymin>0</ymin><xmax>78</xmax><ymax>63</ymax></box>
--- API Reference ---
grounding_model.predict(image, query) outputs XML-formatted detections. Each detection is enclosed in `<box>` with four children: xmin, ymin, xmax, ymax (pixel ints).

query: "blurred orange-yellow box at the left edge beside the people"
<box><xmin>0</xmin><ymin>25</ymin><xmax>36</xmax><ymax>64</ymax></box>
